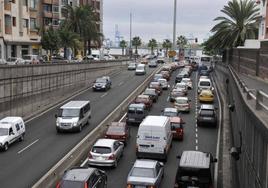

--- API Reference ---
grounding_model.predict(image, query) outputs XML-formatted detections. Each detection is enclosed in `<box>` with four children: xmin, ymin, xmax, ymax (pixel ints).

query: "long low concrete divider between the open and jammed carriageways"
<box><xmin>32</xmin><ymin>65</ymin><xmax>162</xmax><ymax>188</ymax></box>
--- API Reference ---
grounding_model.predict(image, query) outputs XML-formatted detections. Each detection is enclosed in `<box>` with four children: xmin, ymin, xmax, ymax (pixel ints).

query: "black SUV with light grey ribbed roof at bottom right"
<box><xmin>174</xmin><ymin>151</ymin><xmax>217</xmax><ymax>188</ymax></box>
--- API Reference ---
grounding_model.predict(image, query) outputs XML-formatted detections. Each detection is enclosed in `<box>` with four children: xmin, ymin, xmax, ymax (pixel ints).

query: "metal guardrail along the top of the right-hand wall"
<box><xmin>228</xmin><ymin>66</ymin><xmax>268</xmax><ymax>112</ymax></box>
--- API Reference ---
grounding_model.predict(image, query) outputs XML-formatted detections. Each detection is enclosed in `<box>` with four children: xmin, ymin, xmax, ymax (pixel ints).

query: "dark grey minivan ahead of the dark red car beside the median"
<box><xmin>126</xmin><ymin>103</ymin><xmax>148</xmax><ymax>125</ymax></box>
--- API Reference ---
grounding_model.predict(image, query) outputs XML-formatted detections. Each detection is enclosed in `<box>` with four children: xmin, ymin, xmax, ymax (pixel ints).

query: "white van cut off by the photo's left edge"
<box><xmin>0</xmin><ymin>117</ymin><xmax>25</xmax><ymax>151</ymax></box>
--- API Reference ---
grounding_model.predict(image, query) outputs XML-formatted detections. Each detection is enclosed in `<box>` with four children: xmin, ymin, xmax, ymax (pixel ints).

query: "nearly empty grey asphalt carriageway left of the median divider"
<box><xmin>0</xmin><ymin>64</ymin><xmax>158</xmax><ymax>188</ymax></box>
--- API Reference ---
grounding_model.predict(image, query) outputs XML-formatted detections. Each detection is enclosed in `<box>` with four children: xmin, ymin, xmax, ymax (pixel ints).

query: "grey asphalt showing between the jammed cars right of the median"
<box><xmin>102</xmin><ymin>67</ymin><xmax>218</xmax><ymax>188</ymax></box>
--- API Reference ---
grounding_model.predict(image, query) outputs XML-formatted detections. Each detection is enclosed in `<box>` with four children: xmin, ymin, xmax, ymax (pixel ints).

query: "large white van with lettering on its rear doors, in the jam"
<box><xmin>136</xmin><ymin>116</ymin><xmax>172</xmax><ymax>161</ymax></box>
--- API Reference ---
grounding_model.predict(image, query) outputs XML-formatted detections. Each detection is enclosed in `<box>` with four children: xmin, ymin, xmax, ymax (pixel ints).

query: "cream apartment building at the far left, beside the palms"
<box><xmin>0</xmin><ymin>0</ymin><xmax>40</xmax><ymax>59</ymax></box>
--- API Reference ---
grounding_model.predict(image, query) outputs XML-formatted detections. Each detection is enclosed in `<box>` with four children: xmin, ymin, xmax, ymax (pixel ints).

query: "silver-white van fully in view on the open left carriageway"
<box><xmin>55</xmin><ymin>101</ymin><xmax>91</xmax><ymax>132</ymax></box>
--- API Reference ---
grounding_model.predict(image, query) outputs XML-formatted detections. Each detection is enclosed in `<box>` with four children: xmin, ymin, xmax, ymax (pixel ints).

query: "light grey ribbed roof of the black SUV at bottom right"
<box><xmin>180</xmin><ymin>151</ymin><xmax>210</xmax><ymax>169</ymax></box>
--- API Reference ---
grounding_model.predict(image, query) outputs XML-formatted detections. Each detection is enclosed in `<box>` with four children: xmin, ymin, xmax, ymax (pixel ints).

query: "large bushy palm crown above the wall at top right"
<box><xmin>205</xmin><ymin>0</ymin><xmax>259</xmax><ymax>49</ymax></box>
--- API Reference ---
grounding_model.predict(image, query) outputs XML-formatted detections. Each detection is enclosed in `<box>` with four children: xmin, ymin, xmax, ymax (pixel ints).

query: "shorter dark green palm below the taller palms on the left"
<box><xmin>59</xmin><ymin>27</ymin><xmax>79</xmax><ymax>58</ymax></box>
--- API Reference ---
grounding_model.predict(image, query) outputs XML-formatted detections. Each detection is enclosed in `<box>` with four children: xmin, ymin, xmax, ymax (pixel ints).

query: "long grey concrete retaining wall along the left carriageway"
<box><xmin>0</xmin><ymin>61</ymin><xmax>127</xmax><ymax>119</ymax></box>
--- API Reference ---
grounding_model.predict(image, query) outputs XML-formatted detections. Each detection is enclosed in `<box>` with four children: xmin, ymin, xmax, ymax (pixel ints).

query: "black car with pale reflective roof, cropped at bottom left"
<box><xmin>57</xmin><ymin>167</ymin><xmax>107</xmax><ymax>188</ymax></box>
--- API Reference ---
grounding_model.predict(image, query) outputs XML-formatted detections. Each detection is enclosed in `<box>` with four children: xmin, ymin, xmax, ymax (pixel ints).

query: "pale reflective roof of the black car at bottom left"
<box><xmin>63</xmin><ymin>167</ymin><xmax>96</xmax><ymax>181</ymax></box>
